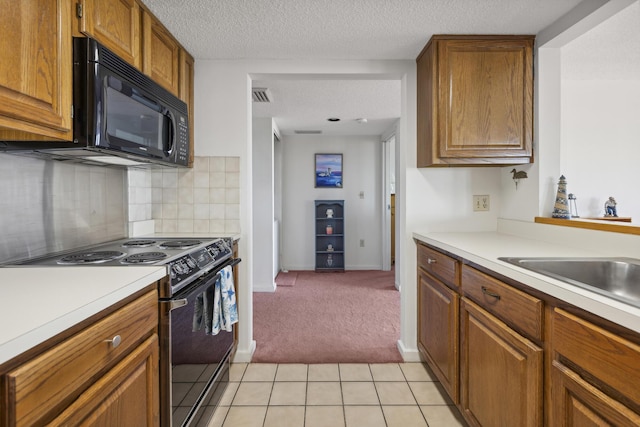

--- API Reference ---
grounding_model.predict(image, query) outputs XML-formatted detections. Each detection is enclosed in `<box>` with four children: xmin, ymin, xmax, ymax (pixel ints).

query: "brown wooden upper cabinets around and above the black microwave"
<box><xmin>0</xmin><ymin>0</ymin><xmax>194</xmax><ymax>162</ymax></box>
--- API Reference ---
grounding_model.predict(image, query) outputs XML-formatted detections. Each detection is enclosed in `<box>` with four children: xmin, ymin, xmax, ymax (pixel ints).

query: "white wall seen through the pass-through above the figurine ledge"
<box><xmin>561</xmin><ymin>80</ymin><xmax>640</xmax><ymax>223</ymax></box>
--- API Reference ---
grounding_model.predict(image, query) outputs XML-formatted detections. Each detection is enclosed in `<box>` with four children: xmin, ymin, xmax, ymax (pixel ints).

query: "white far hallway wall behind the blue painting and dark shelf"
<box><xmin>282</xmin><ymin>135</ymin><xmax>382</xmax><ymax>270</ymax></box>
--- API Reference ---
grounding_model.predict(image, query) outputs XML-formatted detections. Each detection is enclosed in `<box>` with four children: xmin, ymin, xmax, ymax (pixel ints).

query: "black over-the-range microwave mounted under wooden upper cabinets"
<box><xmin>0</xmin><ymin>37</ymin><xmax>190</xmax><ymax>166</ymax></box>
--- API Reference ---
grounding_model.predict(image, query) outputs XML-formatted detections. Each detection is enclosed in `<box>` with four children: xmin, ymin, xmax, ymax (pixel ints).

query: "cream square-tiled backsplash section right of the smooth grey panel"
<box><xmin>128</xmin><ymin>156</ymin><xmax>240</xmax><ymax>234</ymax></box>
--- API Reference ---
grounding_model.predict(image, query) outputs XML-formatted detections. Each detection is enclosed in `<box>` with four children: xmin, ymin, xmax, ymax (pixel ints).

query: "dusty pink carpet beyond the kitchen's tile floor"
<box><xmin>253</xmin><ymin>271</ymin><xmax>402</xmax><ymax>363</ymax></box>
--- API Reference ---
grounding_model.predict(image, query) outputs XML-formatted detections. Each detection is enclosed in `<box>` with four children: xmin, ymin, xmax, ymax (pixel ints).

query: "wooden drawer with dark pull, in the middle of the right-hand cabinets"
<box><xmin>462</xmin><ymin>265</ymin><xmax>544</xmax><ymax>340</ymax></box>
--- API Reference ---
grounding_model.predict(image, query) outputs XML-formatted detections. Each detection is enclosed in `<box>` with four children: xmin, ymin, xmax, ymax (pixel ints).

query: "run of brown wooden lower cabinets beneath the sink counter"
<box><xmin>418</xmin><ymin>242</ymin><xmax>640</xmax><ymax>427</ymax></box>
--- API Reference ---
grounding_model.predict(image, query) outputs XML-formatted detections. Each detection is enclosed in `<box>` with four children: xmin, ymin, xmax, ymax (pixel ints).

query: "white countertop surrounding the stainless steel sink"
<box><xmin>413</xmin><ymin>232</ymin><xmax>640</xmax><ymax>333</ymax></box>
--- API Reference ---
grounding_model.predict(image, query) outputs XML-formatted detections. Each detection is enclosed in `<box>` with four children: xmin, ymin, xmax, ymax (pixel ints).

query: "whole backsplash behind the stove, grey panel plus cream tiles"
<box><xmin>0</xmin><ymin>153</ymin><xmax>240</xmax><ymax>263</ymax></box>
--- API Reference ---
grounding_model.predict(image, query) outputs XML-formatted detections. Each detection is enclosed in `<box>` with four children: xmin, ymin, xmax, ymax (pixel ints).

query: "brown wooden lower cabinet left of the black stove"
<box><xmin>0</xmin><ymin>284</ymin><xmax>160</xmax><ymax>427</ymax></box>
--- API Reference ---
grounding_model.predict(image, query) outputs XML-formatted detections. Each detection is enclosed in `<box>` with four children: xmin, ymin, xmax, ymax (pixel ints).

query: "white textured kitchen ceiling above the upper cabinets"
<box><xmin>143</xmin><ymin>0</ymin><xmax>580</xmax><ymax>60</ymax></box>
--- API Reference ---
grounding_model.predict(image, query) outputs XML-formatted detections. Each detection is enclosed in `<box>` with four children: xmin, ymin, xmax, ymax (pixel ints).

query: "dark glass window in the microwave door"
<box><xmin>105</xmin><ymin>76</ymin><xmax>171</xmax><ymax>155</ymax></box>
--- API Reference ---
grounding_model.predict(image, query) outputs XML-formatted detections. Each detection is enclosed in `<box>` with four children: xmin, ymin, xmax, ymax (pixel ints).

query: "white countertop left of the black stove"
<box><xmin>0</xmin><ymin>266</ymin><xmax>166</xmax><ymax>364</ymax></box>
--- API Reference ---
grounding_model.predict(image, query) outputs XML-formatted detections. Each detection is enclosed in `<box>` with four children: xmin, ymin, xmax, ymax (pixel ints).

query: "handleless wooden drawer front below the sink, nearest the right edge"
<box><xmin>552</xmin><ymin>308</ymin><xmax>640</xmax><ymax>405</ymax></box>
